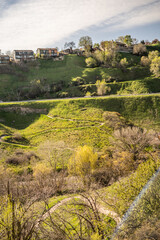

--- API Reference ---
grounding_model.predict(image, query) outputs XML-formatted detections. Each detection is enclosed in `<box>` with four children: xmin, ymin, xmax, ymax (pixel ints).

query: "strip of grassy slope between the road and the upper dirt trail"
<box><xmin>0</xmin><ymin>94</ymin><xmax>160</xmax><ymax>133</ymax></box>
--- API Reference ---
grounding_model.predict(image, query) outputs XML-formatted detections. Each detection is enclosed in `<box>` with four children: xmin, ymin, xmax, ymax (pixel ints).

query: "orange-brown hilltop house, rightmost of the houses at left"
<box><xmin>37</xmin><ymin>48</ymin><xmax>59</xmax><ymax>58</ymax></box>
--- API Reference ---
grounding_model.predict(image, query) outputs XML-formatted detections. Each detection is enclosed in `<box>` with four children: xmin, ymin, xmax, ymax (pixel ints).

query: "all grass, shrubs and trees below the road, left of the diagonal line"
<box><xmin>0</xmin><ymin>95</ymin><xmax>160</xmax><ymax>239</ymax></box>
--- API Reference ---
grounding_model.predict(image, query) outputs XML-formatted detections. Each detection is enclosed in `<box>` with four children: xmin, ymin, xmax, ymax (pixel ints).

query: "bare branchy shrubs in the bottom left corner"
<box><xmin>0</xmin><ymin>185</ymin><xmax>40</xmax><ymax>240</ymax></box>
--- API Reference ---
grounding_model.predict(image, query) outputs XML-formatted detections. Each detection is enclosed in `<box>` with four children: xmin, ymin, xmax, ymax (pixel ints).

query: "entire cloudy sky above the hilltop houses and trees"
<box><xmin>0</xmin><ymin>0</ymin><xmax>160</xmax><ymax>52</ymax></box>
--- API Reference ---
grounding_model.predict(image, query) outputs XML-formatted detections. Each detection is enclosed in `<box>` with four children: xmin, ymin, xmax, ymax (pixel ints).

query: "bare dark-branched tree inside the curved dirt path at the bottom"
<box><xmin>40</xmin><ymin>194</ymin><xmax>114</xmax><ymax>240</ymax></box>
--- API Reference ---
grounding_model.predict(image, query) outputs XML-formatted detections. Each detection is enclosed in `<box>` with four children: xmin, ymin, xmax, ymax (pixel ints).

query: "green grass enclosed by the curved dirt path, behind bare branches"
<box><xmin>35</xmin><ymin>194</ymin><xmax>116</xmax><ymax>239</ymax></box>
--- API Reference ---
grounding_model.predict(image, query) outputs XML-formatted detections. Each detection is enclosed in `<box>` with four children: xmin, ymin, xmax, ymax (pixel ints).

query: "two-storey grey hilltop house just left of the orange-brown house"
<box><xmin>13</xmin><ymin>50</ymin><xmax>35</xmax><ymax>62</ymax></box>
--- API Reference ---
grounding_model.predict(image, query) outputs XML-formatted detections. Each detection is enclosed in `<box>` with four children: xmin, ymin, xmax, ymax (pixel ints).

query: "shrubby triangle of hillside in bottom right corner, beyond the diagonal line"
<box><xmin>115</xmin><ymin>169</ymin><xmax>160</xmax><ymax>239</ymax></box>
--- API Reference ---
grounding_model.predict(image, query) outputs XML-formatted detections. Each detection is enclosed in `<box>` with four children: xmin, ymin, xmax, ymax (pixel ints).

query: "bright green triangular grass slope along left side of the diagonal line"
<box><xmin>99</xmin><ymin>160</ymin><xmax>160</xmax><ymax>217</ymax></box>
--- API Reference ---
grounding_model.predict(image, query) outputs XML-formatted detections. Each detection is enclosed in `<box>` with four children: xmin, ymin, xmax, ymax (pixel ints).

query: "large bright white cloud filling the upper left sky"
<box><xmin>0</xmin><ymin>0</ymin><xmax>158</xmax><ymax>50</ymax></box>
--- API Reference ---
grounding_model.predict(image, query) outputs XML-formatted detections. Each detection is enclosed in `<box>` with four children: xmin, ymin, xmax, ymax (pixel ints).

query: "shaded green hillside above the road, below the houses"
<box><xmin>0</xmin><ymin>53</ymin><xmax>159</xmax><ymax>101</ymax></box>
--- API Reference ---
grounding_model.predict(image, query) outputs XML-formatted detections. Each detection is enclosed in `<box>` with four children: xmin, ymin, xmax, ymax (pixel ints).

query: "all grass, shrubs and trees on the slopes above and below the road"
<box><xmin>0</xmin><ymin>40</ymin><xmax>160</xmax><ymax>240</ymax></box>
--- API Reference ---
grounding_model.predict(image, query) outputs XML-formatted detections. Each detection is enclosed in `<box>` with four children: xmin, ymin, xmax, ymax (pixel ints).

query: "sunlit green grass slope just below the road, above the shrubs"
<box><xmin>0</xmin><ymin>95</ymin><xmax>160</xmax><ymax>172</ymax></box>
